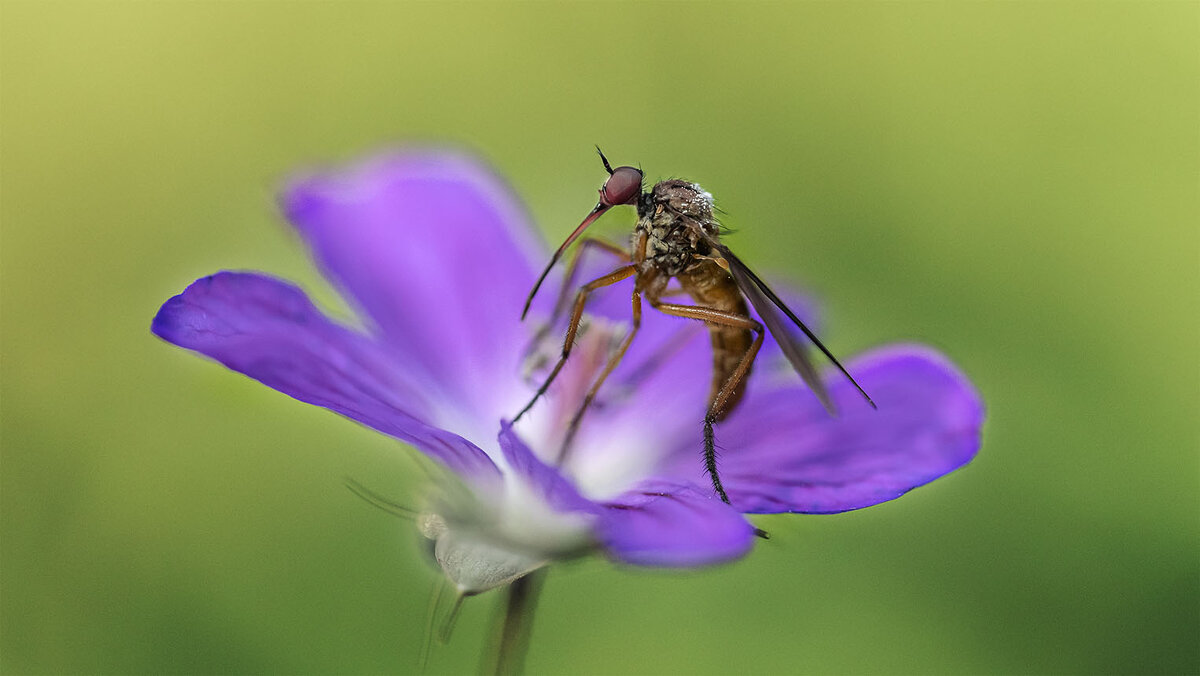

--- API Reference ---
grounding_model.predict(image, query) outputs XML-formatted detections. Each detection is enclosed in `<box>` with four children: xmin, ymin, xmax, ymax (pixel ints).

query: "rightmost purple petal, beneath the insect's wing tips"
<box><xmin>718</xmin><ymin>346</ymin><xmax>984</xmax><ymax>514</ymax></box>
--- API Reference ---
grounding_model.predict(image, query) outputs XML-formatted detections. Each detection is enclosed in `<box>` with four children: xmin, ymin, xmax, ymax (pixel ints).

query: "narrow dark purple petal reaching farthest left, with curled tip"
<box><xmin>151</xmin><ymin>273</ymin><xmax>499</xmax><ymax>481</ymax></box>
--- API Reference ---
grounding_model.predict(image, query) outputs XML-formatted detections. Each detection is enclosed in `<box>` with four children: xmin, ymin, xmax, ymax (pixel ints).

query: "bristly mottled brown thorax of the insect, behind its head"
<box><xmin>634</xmin><ymin>180</ymin><xmax>718</xmax><ymax>276</ymax></box>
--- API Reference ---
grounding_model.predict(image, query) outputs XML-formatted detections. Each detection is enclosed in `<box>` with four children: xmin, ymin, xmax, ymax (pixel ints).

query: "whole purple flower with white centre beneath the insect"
<box><xmin>152</xmin><ymin>152</ymin><xmax>983</xmax><ymax>593</ymax></box>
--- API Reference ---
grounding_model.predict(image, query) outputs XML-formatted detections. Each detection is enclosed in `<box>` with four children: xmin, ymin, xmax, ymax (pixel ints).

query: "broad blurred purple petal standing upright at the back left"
<box><xmin>282</xmin><ymin>152</ymin><xmax>545</xmax><ymax>419</ymax></box>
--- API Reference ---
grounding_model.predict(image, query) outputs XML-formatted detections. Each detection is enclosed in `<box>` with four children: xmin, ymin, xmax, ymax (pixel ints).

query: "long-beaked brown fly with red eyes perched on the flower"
<box><xmin>515</xmin><ymin>148</ymin><xmax>875</xmax><ymax>503</ymax></box>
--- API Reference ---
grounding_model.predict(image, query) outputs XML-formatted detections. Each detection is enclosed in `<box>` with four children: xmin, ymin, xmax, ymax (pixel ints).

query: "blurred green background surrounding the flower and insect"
<box><xmin>0</xmin><ymin>1</ymin><xmax>1200</xmax><ymax>674</ymax></box>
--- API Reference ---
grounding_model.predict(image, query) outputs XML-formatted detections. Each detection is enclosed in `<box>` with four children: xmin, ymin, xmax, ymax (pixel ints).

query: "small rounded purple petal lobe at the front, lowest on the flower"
<box><xmin>600</xmin><ymin>480</ymin><xmax>754</xmax><ymax>567</ymax></box>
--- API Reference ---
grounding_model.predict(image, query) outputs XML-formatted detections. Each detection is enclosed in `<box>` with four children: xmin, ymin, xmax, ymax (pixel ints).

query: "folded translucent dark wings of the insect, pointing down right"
<box><xmin>706</xmin><ymin>237</ymin><xmax>875</xmax><ymax>414</ymax></box>
